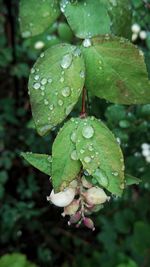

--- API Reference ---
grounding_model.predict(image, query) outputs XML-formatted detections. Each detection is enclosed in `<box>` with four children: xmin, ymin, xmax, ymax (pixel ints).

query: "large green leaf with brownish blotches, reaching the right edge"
<box><xmin>82</xmin><ymin>36</ymin><xmax>150</xmax><ymax>105</ymax></box>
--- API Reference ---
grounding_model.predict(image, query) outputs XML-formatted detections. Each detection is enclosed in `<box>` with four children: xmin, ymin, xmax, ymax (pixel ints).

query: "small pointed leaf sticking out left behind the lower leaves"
<box><xmin>21</xmin><ymin>152</ymin><xmax>52</xmax><ymax>176</ymax></box>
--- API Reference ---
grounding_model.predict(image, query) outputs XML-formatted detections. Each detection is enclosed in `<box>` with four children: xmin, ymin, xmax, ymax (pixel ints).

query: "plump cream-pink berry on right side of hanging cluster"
<box><xmin>84</xmin><ymin>187</ymin><xmax>110</xmax><ymax>205</ymax></box>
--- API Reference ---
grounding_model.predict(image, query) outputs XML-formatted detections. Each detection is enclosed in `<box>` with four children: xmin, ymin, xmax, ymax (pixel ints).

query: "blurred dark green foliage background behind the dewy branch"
<box><xmin>0</xmin><ymin>0</ymin><xmax>150</xmax><ymax>267</ymax></box>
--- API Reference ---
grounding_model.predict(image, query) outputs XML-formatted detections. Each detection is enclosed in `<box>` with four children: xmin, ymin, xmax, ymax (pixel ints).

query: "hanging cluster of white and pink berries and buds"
<box><xmin>47</xmin><ymin>176</ymin><xmax>110</xmax><ymax>231</ymax></box>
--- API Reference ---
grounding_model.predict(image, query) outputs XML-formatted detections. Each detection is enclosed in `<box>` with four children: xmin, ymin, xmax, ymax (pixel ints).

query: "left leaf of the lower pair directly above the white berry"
<box><xmin>52</xmin><ymin>119</ymin><xmax>81</xmax><ymax>191</ymax></box>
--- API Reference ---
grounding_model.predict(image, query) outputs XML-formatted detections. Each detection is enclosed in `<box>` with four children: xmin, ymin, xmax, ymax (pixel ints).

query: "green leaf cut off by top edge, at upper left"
<box><xmin>19</xmin><ymin>0</ymin><xmax>60</xmax><ymax>38</ymax></box>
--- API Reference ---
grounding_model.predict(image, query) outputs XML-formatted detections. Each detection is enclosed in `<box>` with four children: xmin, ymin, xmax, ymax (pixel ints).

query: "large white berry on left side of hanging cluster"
<box><xmin>47</xmin><ymin>187</ymin><xmax>75</xmax><ymax>207</ymax></box>
